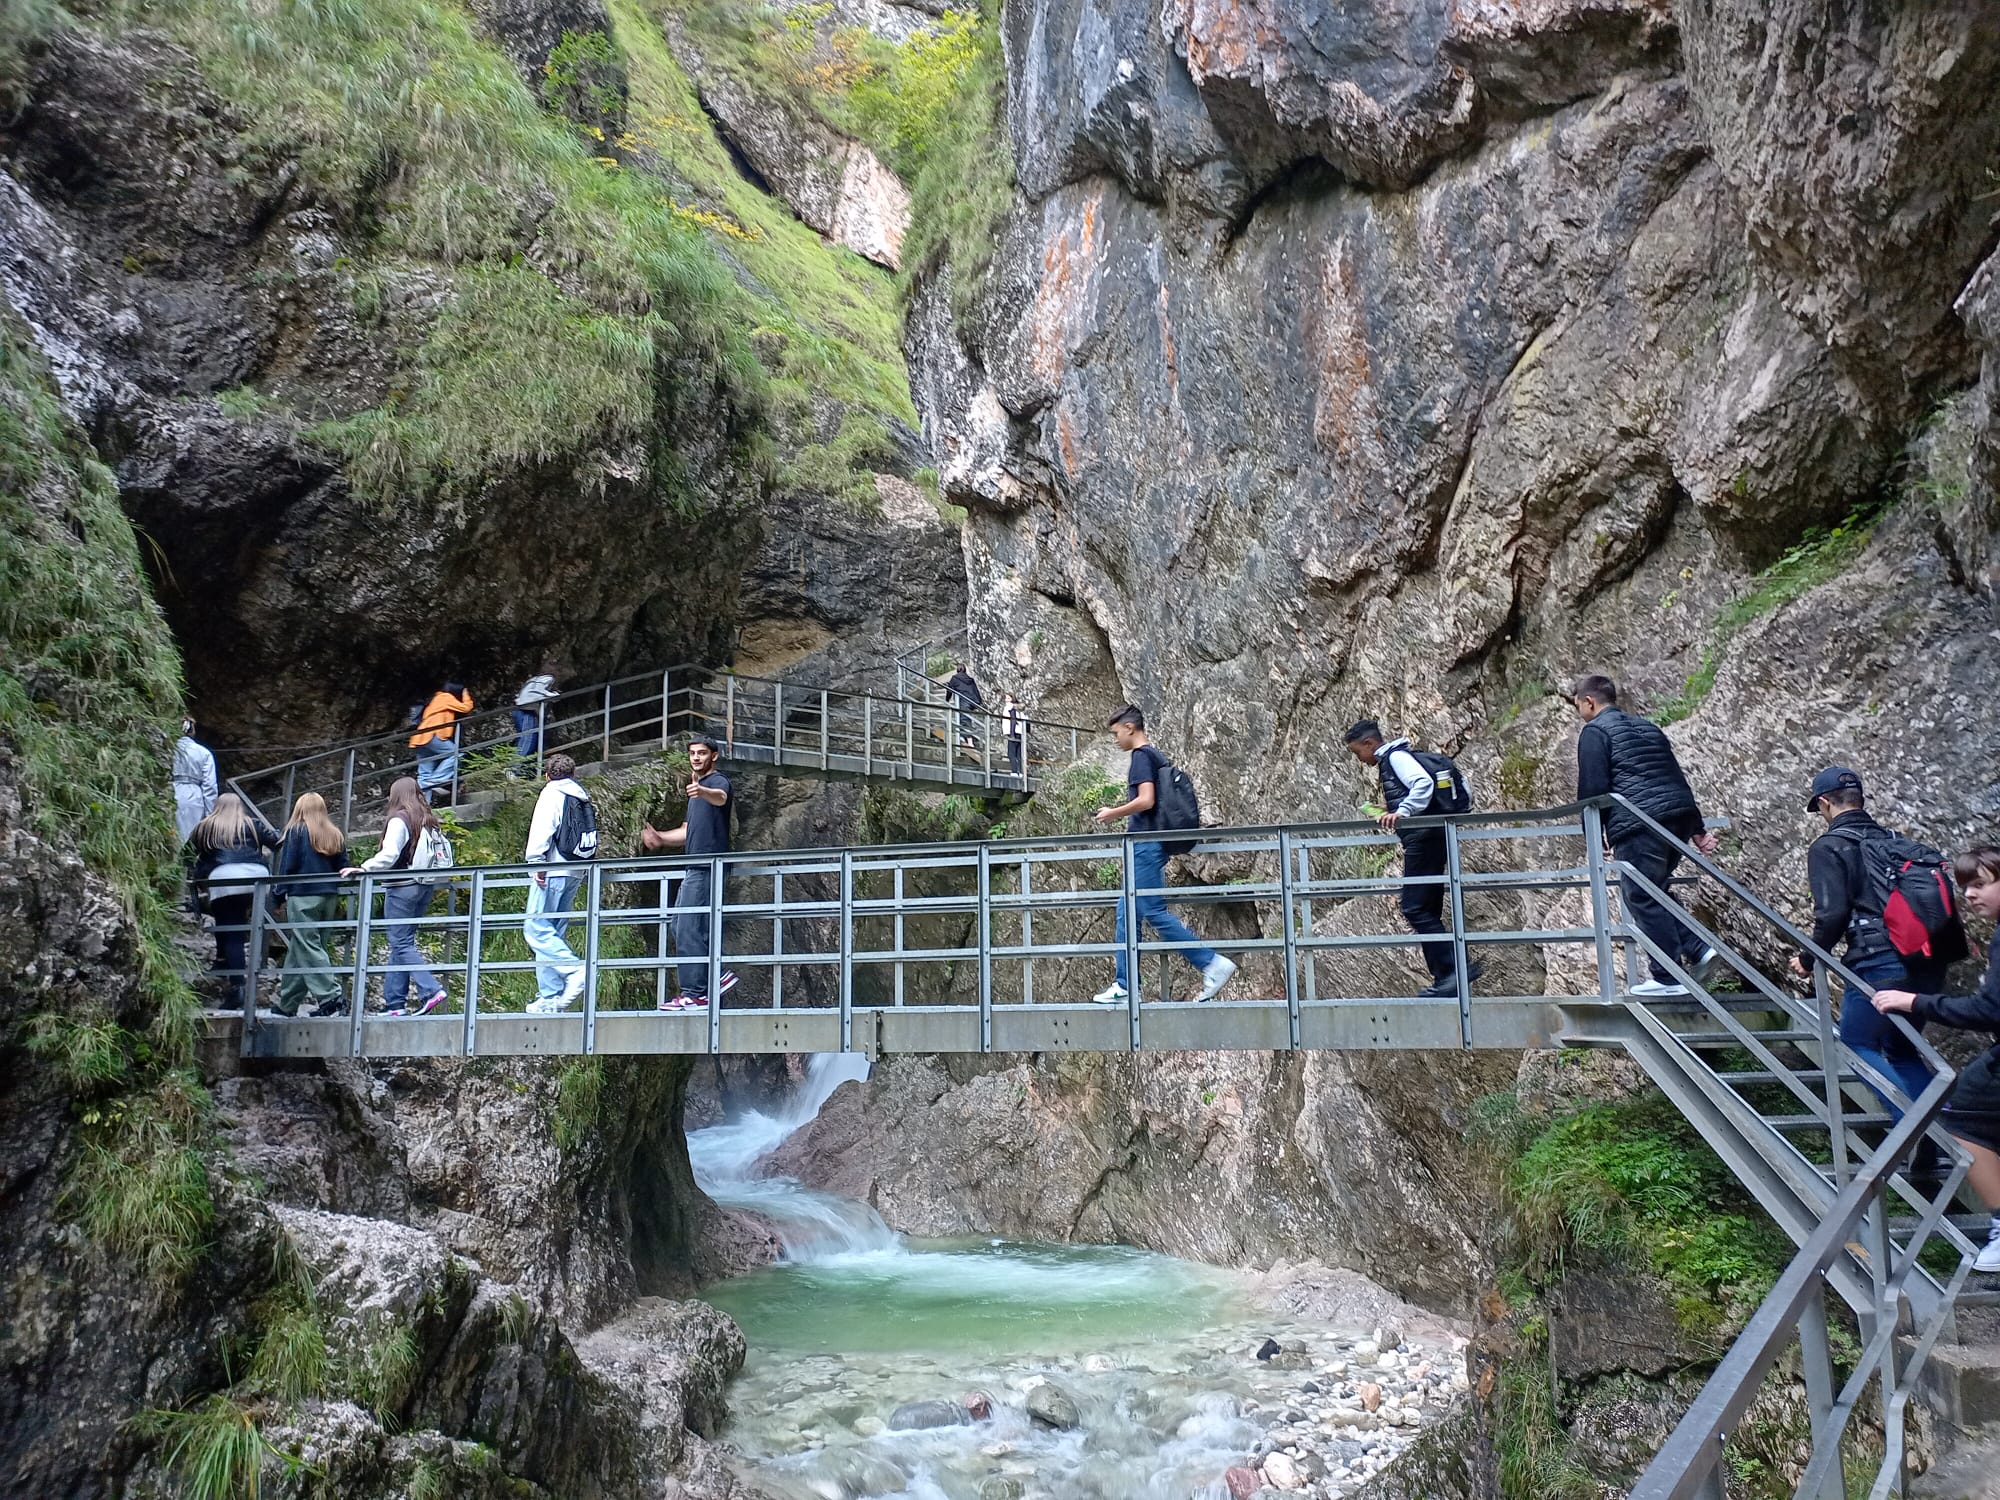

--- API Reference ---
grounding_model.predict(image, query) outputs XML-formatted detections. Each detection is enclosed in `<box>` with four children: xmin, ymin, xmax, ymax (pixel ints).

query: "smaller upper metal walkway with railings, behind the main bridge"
<box><xmin>226</xmin><ymin>660</ymin><xmax>1104</xmax><ymax>832</ymax></box>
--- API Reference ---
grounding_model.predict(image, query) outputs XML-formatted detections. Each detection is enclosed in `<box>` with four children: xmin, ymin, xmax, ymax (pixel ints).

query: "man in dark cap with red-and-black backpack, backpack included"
<box><xmin>1792</xmin><ymin>766</ymin><xmax>1966</xmax><ymax>1114</ymax></box>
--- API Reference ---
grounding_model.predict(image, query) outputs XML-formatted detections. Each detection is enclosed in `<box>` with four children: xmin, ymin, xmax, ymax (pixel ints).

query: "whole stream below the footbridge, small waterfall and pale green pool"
<box><xmin>688</xmin><ymin>1054</ymin><xmax>1440</xmax><ymax>1500</ymax></box>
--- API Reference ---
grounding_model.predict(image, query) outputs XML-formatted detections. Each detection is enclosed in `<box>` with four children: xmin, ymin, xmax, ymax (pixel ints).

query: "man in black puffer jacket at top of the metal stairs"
<box><xmin>1570</xmin><ymin>676</ymin><xmax>1716</xmax><ymax>996</ymax></box>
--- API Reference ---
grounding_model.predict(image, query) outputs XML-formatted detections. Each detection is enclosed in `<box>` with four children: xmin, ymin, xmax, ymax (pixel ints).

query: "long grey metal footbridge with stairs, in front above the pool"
<box><xmin>216</xmin><ymin>798</ymin><xmax>1994</xmax><ymax>1500</ymax></box>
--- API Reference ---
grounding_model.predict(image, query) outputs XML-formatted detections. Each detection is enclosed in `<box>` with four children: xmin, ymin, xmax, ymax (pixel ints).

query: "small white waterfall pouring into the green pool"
<box><xmin>688</xmin><ymin>1052</ymin><xmax>902</xmax><ymax>1262</ymax></box>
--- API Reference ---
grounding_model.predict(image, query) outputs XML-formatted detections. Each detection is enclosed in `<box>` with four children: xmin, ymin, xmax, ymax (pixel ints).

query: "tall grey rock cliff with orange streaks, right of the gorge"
<box><xmin>828</xmin><ymin>0</ymin><xmax>2000</xmax><ymax>1306</ymax></box>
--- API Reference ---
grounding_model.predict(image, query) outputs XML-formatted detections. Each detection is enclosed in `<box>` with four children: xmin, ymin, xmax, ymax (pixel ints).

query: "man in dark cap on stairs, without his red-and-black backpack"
<box><xmin>1792</xmin><ymin>766</ymin><xmax>1944</xmax><ymax>1112</ymax></box>
